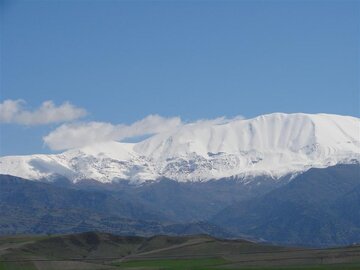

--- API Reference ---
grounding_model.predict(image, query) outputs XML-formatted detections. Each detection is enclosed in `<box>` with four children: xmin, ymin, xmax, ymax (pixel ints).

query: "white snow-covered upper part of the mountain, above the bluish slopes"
<box><xmin>0</xmin><ymin>113</ymin><xmax>360</xmax><ymax>183</ymax></box>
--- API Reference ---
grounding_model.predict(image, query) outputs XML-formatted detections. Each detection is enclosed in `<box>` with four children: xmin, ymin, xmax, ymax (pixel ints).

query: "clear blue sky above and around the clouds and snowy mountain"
<box><xmin>0</xmin><ymin>0</ymin><xmax>360</xmax><ymax>155</ymax></box>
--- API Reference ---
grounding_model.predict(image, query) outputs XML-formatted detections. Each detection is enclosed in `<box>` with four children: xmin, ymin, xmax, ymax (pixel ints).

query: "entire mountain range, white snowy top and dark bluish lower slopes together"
<box><xmin>0</xmin><ymin>113</ymin><xmax>360</xmax><ymax>246</ymax></box>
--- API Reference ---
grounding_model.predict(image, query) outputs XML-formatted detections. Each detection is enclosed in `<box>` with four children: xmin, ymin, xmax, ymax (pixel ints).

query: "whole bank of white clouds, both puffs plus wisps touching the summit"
<box><xmin>0</xmin><ymin>99</ymin><xmax>242</xmax><ymax>151</ymax></box>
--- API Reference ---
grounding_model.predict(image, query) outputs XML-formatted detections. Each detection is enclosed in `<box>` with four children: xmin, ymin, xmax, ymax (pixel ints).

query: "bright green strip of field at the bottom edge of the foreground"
<box><xmin>116</xmin><ymin>258</ymin><xmax>227</xmax><ymax>270</ymax></box>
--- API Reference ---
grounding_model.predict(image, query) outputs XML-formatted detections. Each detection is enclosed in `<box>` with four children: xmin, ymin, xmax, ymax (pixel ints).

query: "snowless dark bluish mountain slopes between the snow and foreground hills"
<box><xmin>0</xmin><ymin>164</ymin><xmax>360</xmax><ymax>247</ymax></box>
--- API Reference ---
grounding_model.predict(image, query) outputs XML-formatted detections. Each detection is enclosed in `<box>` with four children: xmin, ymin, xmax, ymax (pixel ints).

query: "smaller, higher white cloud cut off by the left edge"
<box><xmin>0</xmin><ymin>99</ymin><xmax>86</xmax><ymax>125</ymax></box>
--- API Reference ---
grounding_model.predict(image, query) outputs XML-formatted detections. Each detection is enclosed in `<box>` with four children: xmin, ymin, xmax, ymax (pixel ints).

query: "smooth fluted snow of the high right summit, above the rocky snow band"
<box><xmin>135</xmin><ymin>113</ymin><xmax>359</xmax><ymax>159</ymax></box>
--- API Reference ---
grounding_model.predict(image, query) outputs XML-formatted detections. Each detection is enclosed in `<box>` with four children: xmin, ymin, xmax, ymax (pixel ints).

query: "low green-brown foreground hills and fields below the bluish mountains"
<box><xmin>0</xmin><ymin>232</ymin><xmax>360</xmax><ymax>270</ymax></box>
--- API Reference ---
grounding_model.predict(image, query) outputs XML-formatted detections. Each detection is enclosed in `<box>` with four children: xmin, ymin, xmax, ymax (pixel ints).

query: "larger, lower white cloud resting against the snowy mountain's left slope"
<box><xmin>43</xmin><ymin>115</ymin><xmax>182</xmax><ymax>150</ymax></box>
